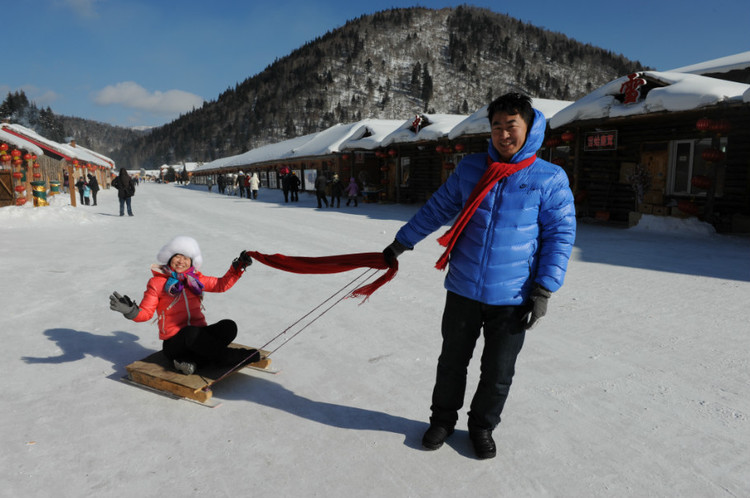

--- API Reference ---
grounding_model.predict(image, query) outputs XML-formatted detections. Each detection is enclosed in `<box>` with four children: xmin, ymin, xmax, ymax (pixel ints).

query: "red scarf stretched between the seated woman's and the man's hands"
<box><xmin>247</xmin><ymin>251</ymin><xmax>398</xmax><ymax>299</ymax></box>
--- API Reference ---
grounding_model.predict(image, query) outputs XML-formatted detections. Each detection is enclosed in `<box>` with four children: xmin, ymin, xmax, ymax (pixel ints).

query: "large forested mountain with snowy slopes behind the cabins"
<box><xmin>5</xmin><ymin>6</ymin><xmax>643</xmax><ymax>169</ymax></box>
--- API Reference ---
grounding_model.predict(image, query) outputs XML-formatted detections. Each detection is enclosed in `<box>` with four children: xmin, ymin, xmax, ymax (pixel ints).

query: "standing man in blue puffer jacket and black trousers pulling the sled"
<box><xmin>383</xmin><ymin>94</ymin><xmax>576</xmax><ymax>458</ymax></box>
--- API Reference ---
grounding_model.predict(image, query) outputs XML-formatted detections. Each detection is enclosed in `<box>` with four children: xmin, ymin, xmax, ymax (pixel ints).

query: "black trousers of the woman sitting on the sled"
<box><xmin>162</xmin><ymin>320</ymin><xmax>237</xmax><ymax>367</ymax></box>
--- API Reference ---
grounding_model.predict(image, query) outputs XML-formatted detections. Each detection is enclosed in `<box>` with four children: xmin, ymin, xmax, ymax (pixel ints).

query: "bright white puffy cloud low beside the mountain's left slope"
<box><xmin>94</xmin><ymin>81</ymin><xmax>203</xmax><ymax>114</ymax></box>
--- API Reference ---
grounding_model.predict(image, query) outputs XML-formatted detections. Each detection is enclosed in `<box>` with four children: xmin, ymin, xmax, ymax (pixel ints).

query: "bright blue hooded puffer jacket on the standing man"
<box><xmin>396</xmin><ymin>111</ymin><xmax>576</xmax><ymax>306</ymax></box>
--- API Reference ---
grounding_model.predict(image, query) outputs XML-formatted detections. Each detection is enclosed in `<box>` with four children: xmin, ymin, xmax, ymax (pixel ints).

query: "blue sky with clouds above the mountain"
<box><xmin>0</xmin><ymin>0</ymin><xmax>750</xmax><ymax>126</ymax></box>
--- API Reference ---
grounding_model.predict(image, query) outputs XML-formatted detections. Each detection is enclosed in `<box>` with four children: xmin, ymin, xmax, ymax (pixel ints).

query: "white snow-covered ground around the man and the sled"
<box><xmin>0</xmin><ymin>184</ymin><xmax>750</xmax><ymax>497</ymax></box>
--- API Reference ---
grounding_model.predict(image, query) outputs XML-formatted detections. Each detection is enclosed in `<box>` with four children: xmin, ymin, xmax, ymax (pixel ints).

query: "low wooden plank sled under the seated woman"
<box><xmin>125</xmin><ymin>343</ymin><xmax>271</xmax><ymax>403</ymax></box>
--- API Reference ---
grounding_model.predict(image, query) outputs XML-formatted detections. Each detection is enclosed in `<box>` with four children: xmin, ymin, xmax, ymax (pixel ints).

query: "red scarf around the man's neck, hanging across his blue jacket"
<box><xmin>435</xmin><ymin>155</ymin><xmax>537</xmax><ymax>270</ymax></box>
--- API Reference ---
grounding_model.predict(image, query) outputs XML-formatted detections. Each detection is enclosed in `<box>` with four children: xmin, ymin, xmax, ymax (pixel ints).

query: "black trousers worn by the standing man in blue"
<box><xmin>430</xmin><ymin>292</ymin><xmax>526</xmax><ymax>430</ymax></box>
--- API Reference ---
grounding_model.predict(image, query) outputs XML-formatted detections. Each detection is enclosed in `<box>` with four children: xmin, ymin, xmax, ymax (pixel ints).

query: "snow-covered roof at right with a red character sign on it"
<box><xmin>550</xmin><ymin>71</ymin><xmax>750</xmax><ymax>129</ymax></box>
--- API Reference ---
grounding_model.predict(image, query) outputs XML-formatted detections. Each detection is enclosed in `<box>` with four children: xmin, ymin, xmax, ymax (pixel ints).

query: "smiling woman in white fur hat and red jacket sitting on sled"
<box><xmin>109</xmin><ymin>236</ymin><xmax>261</xmax><ymax>375</ymax></box>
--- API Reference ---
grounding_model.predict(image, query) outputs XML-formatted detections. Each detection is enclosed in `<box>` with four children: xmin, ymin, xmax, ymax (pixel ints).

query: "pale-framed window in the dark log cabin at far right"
<box><xmin>668</xmin><ymin>138</ymin><xmax>727</xmax><ymax>196</ymax></box>
